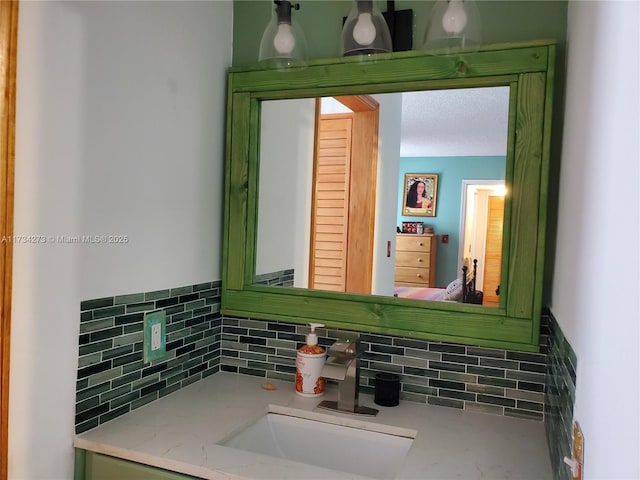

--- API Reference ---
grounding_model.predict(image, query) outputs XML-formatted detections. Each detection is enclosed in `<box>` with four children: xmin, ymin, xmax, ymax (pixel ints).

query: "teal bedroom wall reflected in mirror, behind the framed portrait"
<box><xmin>398</xmin><ymin>156</ymin><xmax>506</xmax><ymax>287</ymax></box>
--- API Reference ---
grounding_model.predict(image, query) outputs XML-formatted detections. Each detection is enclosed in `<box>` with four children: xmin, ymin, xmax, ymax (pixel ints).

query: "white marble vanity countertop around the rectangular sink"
<box><xmin>74</xmin><ymin>372</ymin><xmax>552</xmax><ymax>480</ymax></box>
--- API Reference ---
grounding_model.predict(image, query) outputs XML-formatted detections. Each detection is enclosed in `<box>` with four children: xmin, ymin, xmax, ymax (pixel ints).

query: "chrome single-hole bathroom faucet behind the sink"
<box><xmin>318</xmin><ymin>337</ymin><xmax>378</xmax><ymax>415</ymax></box>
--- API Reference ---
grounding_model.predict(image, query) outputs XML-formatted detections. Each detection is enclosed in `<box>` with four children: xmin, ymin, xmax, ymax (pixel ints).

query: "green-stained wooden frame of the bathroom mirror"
<box><xmin>221</xmin><ymin>41</ymin><xmax>555</xmax><ymax>351</ymax></box>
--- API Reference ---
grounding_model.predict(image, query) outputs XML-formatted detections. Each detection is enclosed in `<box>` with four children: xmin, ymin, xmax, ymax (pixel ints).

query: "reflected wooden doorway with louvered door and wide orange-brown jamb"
<box><xmin>309</xmin><ymin>95</ymin><xmax>379</xmax><ymax>293</ymax></box>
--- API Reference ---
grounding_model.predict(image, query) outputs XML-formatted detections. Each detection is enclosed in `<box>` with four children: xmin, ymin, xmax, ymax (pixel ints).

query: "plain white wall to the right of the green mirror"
<box><xmin>551</xmin><ymin>1</ymin><xmax>640</xmax><ymax>480</ymax></box>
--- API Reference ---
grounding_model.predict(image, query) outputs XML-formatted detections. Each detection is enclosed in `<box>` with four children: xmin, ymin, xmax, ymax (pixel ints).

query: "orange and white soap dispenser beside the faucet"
<box><xmin>296</xmin><ymin>323</ymin><xmax>326</xmax><ymax>397</ymax></box>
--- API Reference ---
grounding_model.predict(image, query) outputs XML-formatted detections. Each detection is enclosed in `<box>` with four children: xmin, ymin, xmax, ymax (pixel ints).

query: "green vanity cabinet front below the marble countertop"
<box><xmin>74</xmin><ymin>449</ymin><xmax>198</xmax><ymax>480</ymax></box>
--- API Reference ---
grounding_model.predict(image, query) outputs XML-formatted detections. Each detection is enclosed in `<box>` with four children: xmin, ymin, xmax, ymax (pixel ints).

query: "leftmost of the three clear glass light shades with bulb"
<box><xmin>258</xmin><ymin>0</ymin><xmax>307</xmax><ymax>69</ymax></box>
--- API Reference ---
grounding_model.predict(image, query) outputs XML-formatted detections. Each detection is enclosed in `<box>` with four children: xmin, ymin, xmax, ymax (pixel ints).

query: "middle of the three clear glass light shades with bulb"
<box><xmin>340</xmin><ymin>0</ymin><xmax>393</xmax><ymax>57</ymax></box>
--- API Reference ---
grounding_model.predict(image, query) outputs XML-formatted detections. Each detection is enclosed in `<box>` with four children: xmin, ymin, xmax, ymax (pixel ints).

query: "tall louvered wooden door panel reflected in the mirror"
<box><xmin>309</xmin><ymin>114</ymin><xmax>353</xmax><ymax>292</ymax></box>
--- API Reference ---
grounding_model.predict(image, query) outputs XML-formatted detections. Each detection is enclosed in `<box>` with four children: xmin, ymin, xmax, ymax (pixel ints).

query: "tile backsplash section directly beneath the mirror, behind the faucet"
<box><xmin>220</xmin><ymin>317</ymin><xmax>546</xmax><ymax>420</ymax></box>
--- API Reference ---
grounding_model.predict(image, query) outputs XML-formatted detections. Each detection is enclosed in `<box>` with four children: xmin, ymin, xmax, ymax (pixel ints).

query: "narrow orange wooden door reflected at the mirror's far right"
<box><xmin>482</xmin><ymin>195</ymin><xmax>504</xmax><ymax>306</ymax></box>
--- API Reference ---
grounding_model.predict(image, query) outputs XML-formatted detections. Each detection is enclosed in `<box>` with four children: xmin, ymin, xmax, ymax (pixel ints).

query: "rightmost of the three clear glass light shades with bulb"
<box><xmin>424</xmin><ymin>0</ymin><xmax>482</xmax><ymax>53</ymax></box>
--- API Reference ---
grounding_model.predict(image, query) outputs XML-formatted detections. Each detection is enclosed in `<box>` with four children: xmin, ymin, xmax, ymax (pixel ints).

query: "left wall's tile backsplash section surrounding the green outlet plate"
<box><xmin>75</xmin><ymin>282</ymin><xmax>222</xmax><ymax>433</ymax></box>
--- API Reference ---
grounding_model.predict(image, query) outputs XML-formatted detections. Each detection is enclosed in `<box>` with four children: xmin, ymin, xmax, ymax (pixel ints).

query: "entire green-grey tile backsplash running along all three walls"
<box><xmin>75</xmin><ymin>284</ymin><xmax>576</xmax><ymax>454</ymax></box>
